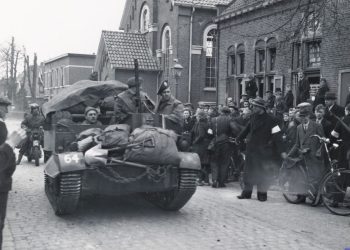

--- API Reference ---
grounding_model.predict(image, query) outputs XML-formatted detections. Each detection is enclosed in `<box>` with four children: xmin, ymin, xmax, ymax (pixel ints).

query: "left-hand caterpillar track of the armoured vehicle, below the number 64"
<box><xmin>45</xmin><ymin>173</ymin><xmax>82</xmax><ymax>215</ymax></box>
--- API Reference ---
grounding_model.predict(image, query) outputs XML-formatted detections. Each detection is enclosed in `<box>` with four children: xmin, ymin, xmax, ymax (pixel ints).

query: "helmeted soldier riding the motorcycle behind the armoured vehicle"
<box><xmin>17</xmin><ymin>103</ymin><xmax>45</xmax><ymax>165</ymax></box>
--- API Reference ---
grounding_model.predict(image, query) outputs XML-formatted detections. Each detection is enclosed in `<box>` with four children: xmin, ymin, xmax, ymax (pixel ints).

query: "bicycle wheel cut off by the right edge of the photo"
<box><xmin>321</xmin><ymin>169</ymin><xmax>350</xmax><ymax>216</ymax></box>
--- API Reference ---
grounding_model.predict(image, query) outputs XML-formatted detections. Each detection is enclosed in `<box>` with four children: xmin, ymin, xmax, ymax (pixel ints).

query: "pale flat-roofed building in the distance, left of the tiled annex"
<box><xmin>43</xmin><ymin>53</ymin><xmax>96</xmax><ymax>99</ymax></box>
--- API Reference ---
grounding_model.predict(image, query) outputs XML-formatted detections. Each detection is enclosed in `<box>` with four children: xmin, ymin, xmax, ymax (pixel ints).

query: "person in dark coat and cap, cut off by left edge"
<box><xmin>0</xmin><ymin>97</ymin><xmax>16</xmax><ymax>249</ymax></box>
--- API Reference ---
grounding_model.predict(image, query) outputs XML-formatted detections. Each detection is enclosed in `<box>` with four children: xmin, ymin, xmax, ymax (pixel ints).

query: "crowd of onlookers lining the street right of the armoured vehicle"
<box><xmin>183</xmin><ymin>79</ymin><xmax>350</xmax><ymax>201</ymax></box>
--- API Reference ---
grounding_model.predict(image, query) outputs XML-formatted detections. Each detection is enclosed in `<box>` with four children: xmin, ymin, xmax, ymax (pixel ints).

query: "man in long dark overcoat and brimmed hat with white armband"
<box><xmin>237</xmin><ymin>97</ymin><xmax>287</xmax><ymax>201</ymax></box>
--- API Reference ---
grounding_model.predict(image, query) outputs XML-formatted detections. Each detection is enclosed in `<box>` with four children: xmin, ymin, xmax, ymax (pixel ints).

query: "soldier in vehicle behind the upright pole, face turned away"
<box><xmin>111</xmin><ymin>77</ymin><xmax>154</xmax><ymax>124</ymax></box>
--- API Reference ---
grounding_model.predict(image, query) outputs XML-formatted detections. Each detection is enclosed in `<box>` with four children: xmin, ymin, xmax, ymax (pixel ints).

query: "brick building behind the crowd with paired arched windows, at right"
<box><xmin>215</xmin><ymin>0</ymin><xmax>350</xmax><ymax>104</ymax></box>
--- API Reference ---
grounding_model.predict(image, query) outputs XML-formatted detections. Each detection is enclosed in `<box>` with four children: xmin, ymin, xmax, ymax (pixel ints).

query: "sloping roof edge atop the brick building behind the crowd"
<box><xmin>215</xmin><ymin>0</ymin><xmax>284</xmax><ymax>22</ymax></box>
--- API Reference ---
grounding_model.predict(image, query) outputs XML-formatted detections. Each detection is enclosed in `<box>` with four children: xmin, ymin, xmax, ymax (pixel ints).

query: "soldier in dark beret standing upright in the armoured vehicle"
<box><xmin>155</xmin><ymin>81</ymin><xmax>184</xmax><ymax>133</ymax></box>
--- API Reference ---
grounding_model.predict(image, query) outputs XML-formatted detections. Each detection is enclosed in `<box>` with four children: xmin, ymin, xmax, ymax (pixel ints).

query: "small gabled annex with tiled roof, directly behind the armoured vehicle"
<box><xmin>95</xmin><ymin>31</ymin><xmax>159</xmax><ymax>100</ymax></box>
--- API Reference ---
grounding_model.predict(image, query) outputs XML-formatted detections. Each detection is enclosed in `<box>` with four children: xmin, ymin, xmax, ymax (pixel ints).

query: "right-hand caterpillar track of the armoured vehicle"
<box><xmin>146</xmin><ymin>169</ymin><xmax>198</xmax><ymax>211</ymax></box>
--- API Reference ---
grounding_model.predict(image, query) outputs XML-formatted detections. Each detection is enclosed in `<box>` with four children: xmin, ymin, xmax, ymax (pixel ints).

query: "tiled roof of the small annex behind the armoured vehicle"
<box><xmin>102</xmin><ymin>30</ymin><xmax>159</xmax><ymax>71</ymax></box>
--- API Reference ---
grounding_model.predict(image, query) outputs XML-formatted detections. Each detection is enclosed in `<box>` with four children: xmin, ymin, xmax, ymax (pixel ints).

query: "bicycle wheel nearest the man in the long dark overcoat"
<box><xmin>279</xmin><ymin>166</ymin><xmax>307</xmax><ymax>204</ymax></box>
